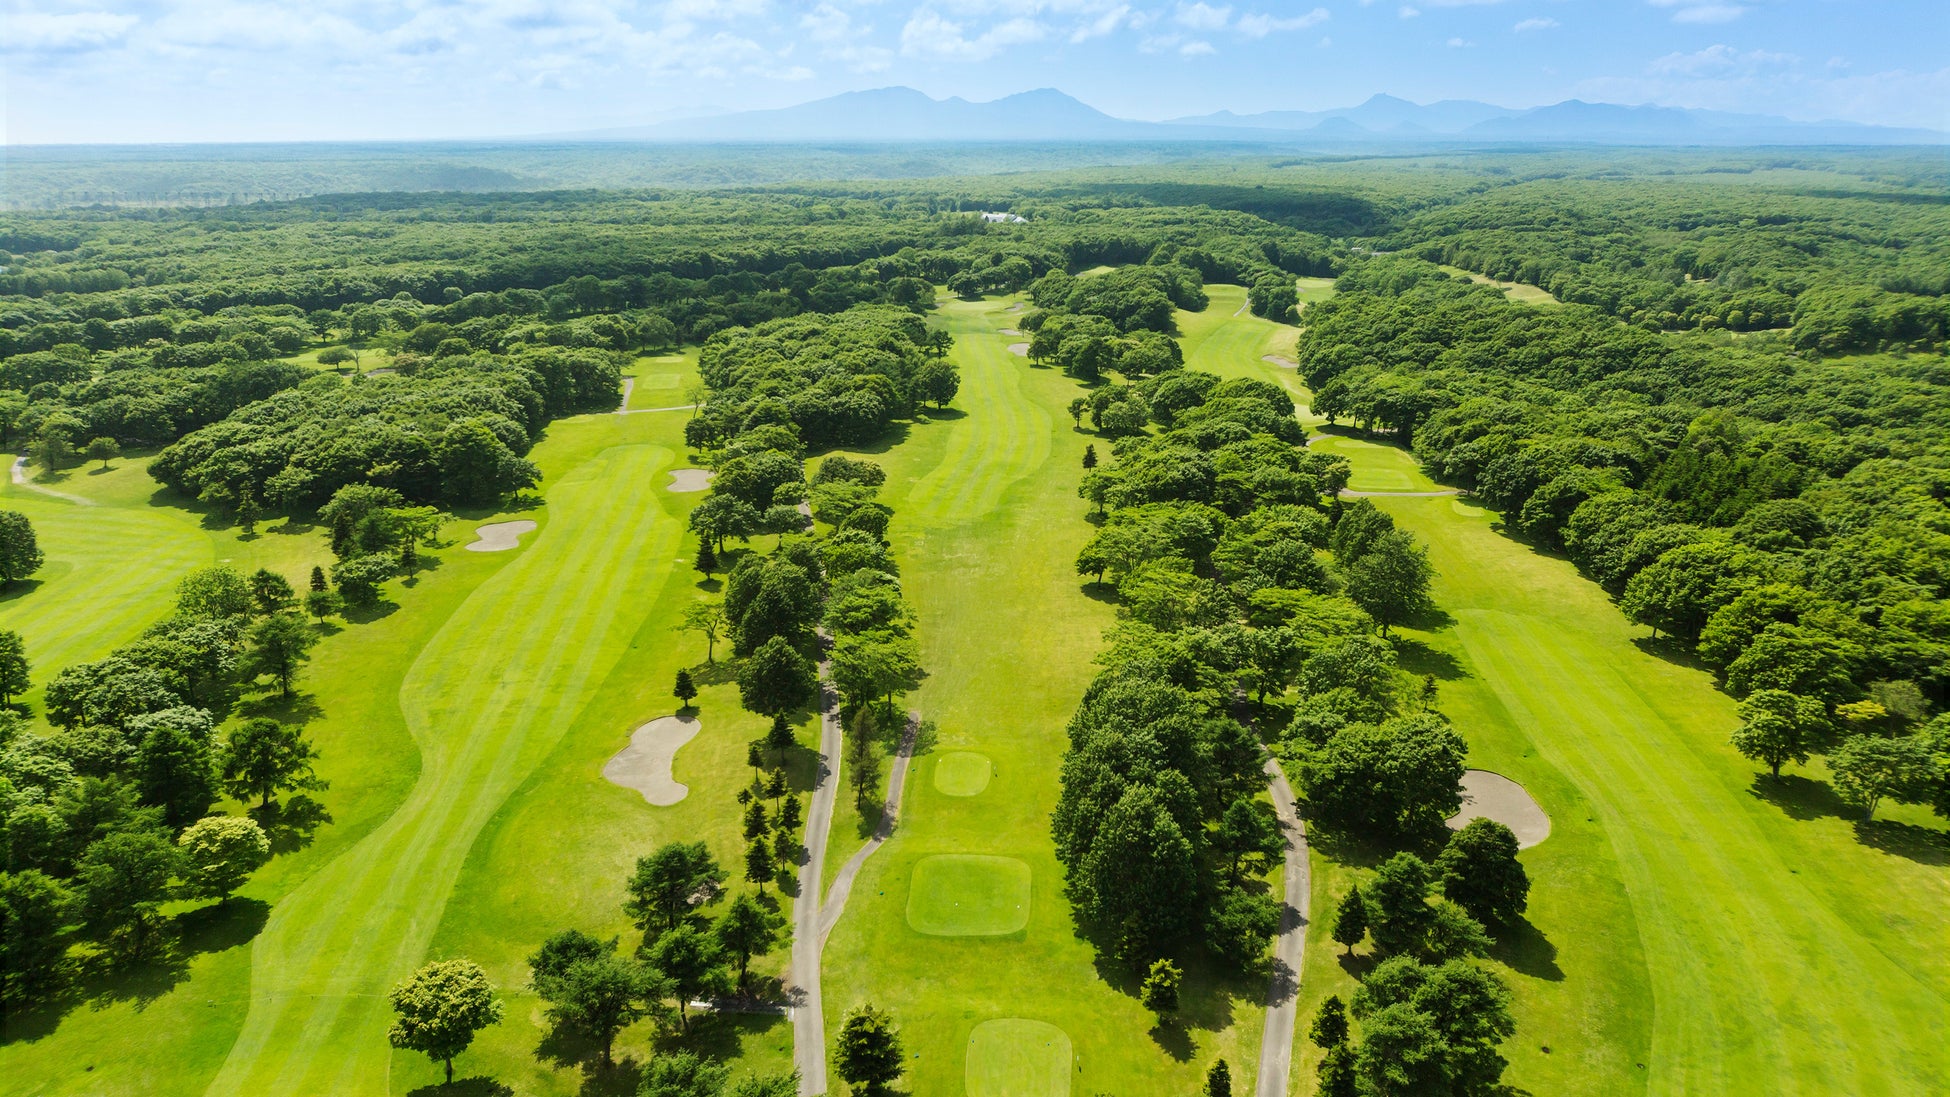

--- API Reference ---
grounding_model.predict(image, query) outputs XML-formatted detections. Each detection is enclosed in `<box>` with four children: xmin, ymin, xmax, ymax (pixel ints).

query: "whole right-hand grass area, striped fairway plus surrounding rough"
<box><xmin>1207</xmin><ymin>288</ymin><xmax>1950</xmax><ymax>1095</ymax></box>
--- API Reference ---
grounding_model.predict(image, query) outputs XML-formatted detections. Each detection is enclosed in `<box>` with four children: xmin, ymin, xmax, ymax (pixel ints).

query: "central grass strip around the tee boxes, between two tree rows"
<box><xmin>823</xmin><ymin>300</ymin><xmax>1266</xmax><ymax>1097</ymax></box>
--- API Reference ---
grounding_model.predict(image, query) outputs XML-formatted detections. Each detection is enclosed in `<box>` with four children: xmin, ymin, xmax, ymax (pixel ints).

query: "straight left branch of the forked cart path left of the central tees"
<box><xmin>786</xmin><ymin>639</ymin><xmax>840</xmax><ymax>1097</ymax></box>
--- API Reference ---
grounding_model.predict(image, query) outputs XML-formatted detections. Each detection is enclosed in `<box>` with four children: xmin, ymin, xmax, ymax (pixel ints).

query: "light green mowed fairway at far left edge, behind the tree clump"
<box><xmin>0</xmin><ymin>483</ymin><xmax>216</xmax><ymax>684</ymax></box>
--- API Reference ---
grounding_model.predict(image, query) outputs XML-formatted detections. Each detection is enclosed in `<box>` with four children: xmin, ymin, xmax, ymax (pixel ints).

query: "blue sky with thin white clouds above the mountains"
<box><xmin>11</xmin><ymin>0</ymin><xmax>1950</xmax><ymax>144</ymax></box>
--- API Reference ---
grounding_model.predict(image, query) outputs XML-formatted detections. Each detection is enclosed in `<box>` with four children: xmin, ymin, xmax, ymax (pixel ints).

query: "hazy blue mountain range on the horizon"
<box><xmin>556</xmin><ymin>88</ymin><xmax>1950</xmax><ymax>144</ymax></box>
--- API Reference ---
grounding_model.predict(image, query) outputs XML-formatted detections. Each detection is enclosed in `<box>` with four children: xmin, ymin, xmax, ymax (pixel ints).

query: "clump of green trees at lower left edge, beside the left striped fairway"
<box><xmin>0</xmin><ymin>565</ymin><xmax>324</xmax><ymax>1003</ymax></box>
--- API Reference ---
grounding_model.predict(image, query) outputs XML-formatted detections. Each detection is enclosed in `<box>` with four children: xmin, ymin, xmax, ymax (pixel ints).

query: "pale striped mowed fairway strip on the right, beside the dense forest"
<box><xmin>1388</xmin><ymin>499</ymin><xmax>1950</xmax><ymax>1093</ymax></box>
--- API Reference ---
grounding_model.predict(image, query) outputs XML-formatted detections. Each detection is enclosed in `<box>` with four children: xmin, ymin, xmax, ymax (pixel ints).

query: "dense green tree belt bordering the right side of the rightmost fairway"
<box><xmin>1301</xmin><ymin>259</ymin><xmax>1950</xmax><ymax>833</ymax></box>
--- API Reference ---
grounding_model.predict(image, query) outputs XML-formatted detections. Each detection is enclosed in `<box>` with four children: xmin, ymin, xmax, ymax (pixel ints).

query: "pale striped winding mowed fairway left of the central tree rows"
<box><xmin>211</xmin><ymin>446</ymin><xmax>681</xmax><ymax>1093</ymax></box>
